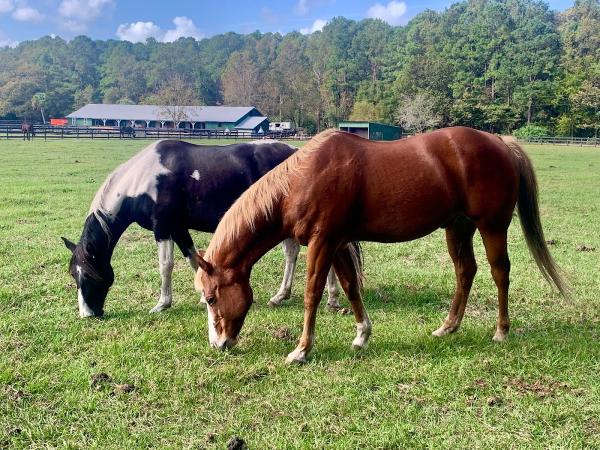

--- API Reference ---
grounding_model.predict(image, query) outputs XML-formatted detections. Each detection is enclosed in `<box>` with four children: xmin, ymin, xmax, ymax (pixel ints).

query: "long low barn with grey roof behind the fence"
<box><xmin>67</xmin><ymin>104</ymin><xmax>269</xmax><ymax>133</ymax></box>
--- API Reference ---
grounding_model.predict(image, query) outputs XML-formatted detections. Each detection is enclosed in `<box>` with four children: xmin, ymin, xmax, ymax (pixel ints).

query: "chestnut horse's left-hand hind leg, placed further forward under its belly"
<box><xmin>432</xmin><ymin>219</ymin><xmax>477</xmax><ymax>337</ymax></box>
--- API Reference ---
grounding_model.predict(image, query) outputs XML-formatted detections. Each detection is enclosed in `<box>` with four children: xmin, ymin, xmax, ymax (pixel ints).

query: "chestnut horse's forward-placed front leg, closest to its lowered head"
<box><xmin>286</xmin><ymin>240</ymin><xmax>334</xmax><ymax>363</ymax></box>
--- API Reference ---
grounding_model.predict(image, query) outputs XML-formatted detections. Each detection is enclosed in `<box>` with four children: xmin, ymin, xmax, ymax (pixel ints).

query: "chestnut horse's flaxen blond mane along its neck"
<box><xmin>206</xmin><ymin>129</ymin><xmax>339</xmax><ymax>258</ymax></box>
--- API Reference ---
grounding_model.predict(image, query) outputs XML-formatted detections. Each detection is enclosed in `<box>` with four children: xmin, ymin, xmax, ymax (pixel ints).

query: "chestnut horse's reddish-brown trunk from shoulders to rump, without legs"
<box><xmin>287</xmin><ymin>127</ymin><xmax>519</xmax><ymax>242</ymax></box>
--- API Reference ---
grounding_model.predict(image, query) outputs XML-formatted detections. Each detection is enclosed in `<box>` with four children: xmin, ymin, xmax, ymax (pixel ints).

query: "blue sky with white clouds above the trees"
<box><xmin>0</xmin><ymin>0</ymin><xmax>574</xmax><ymax>46</ymax></box>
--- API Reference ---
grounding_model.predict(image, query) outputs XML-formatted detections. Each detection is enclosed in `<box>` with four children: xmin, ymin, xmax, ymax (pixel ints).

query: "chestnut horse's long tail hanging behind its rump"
<box><xmin>502</xmin><ymin>137</ymin><xmax>569</xmax><ymax>296</ymax></box>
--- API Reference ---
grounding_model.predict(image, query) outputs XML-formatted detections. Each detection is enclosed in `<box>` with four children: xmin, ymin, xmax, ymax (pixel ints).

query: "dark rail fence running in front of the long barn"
<box><xmin>0</xmin><ymin>124</ymin><xmax>311</xmax><ymax>140</ymax></box>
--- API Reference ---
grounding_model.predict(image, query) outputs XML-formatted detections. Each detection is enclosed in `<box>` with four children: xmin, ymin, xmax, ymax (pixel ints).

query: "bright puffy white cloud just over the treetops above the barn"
<box><xmin>117</xmin><ymin>16</ymin><xmax>203</xmax><ymax>42</ymax></box>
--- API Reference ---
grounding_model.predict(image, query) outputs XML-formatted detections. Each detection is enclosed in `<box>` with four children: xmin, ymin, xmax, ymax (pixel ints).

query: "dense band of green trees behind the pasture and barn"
<box><xmin>0</xmin><ymin>0</ymin><xmax>600</xmax><ymax>136</ymax></box>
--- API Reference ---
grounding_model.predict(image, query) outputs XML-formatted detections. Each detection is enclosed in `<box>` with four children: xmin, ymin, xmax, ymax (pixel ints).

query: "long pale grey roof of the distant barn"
<box><xmin>67</xmin><ymin>103</ymin><xmax>255</xmax><ymax>123</ymax></box>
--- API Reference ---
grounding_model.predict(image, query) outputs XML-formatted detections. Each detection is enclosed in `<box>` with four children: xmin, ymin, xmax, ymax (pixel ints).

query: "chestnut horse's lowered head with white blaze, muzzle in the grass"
<box><xmin>195</xmin><ymin>252</ymin><xmax>253</xmax><ymax>350</ymax></box>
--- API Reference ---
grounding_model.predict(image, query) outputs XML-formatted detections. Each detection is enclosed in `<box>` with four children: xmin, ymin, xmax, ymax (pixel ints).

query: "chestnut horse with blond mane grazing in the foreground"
<box><xmin>195</xmin><ymin>127</ymin><xmax>566</xmax><ymax>362</ymax></box>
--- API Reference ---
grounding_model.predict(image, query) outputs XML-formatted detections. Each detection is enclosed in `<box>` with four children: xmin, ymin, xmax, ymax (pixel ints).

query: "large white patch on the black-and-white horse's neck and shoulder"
<box><xmin>90</xmin><ymin>141</ymin><xmax>171</xmax><ymax>217</ymax></box>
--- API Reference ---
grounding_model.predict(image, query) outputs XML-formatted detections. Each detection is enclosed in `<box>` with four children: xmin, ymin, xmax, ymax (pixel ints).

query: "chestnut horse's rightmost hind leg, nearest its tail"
<box><xmin>480</xmin><ymin>230</ymin><xmax>510</xmax><ymax>342</ymax></box>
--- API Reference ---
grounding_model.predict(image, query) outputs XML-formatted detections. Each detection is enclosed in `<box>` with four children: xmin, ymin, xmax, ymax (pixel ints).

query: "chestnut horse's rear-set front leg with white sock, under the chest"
<box><xmin>333</xmin><ymin>246</ymin><xmax>371</xmax><ymax>350</ymax></box>
